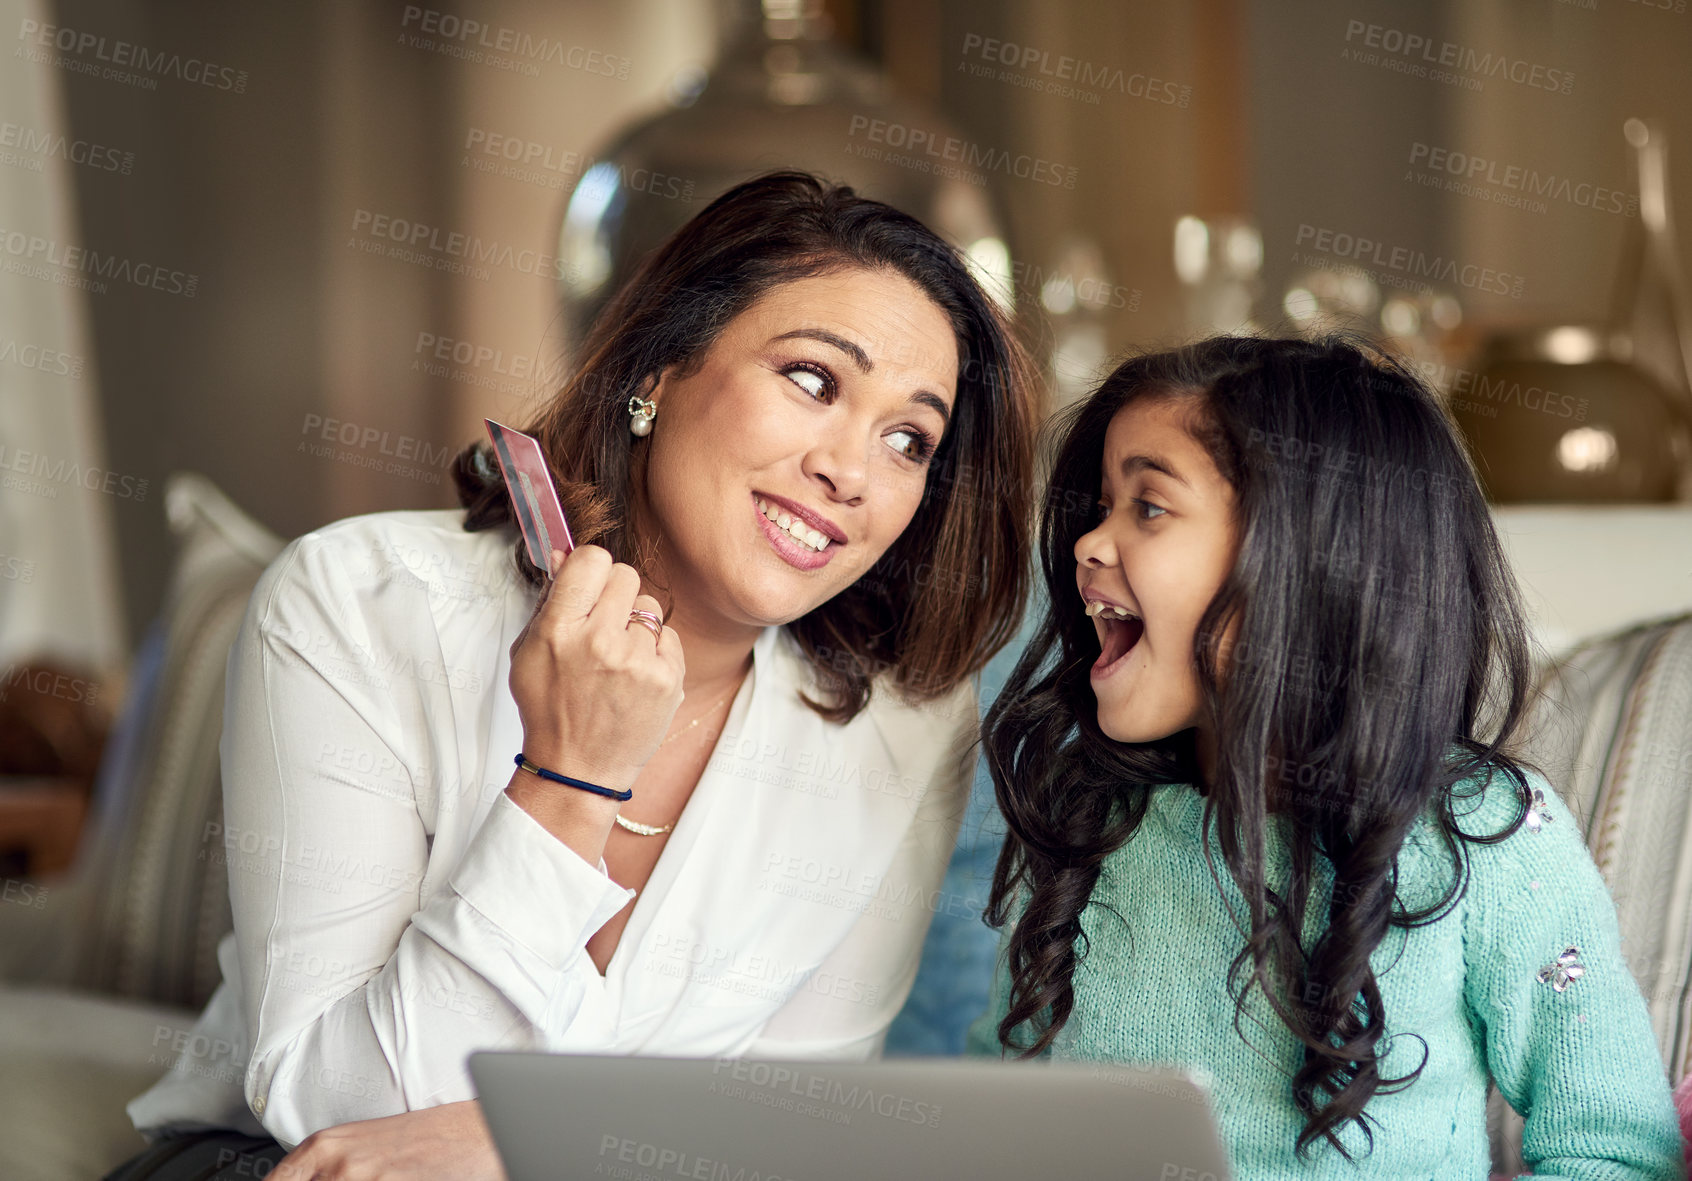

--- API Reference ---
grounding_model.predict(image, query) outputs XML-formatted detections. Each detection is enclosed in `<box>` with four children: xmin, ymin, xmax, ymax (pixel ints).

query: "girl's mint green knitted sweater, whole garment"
<box><xmin>968</xmin><ymin>758</ymin><xmax>1684</xmax><ymax>1181</ymax></box>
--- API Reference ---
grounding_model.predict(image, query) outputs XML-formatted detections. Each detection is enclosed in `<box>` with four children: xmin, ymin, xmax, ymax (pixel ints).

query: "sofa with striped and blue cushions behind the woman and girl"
<box><xmin>0</xmin><ymin>474</ymin><xmax>1692</xmax><ymax>1181</ymax></box>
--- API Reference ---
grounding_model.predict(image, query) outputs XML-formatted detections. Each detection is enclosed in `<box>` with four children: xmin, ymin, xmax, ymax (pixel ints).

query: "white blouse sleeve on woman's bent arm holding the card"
<box><xmin>220</xmin><ymin>533</ymin><xmax>633</xmax><ymax>1144</ymax></box>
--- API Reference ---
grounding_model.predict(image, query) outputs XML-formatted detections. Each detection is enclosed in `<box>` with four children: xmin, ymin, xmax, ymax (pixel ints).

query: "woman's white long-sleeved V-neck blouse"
<box><xmin>129</xmin><ymin>509</ymin><xmax>976</xmax><ymax>1147</ymax></box>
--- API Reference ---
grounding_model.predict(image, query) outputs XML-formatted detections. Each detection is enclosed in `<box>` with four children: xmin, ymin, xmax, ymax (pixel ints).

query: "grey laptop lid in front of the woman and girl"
<box><xmin>470</xmin><ymin>1051</ymin><xmax>1228</xmax><ymax>1181</ymax></box>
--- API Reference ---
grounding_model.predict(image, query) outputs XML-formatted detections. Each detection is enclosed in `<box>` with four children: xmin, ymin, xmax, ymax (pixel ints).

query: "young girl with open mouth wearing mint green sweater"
<box><xmin>970</xmin><ymin>338</ymin><xmax>1682</xmax><ymax>1179</ymax></box>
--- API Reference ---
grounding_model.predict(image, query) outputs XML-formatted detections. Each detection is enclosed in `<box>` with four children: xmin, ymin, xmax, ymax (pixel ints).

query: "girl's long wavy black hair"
<box><xmin>983</xmin><ymin>337</ymin><xmax>1530</xmax><ymax>1157</ymax></box>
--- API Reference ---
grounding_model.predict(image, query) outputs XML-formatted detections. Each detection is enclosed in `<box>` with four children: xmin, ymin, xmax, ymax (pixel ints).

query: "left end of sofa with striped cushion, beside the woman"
<box><xmin>0</xmin><ymin>474</ymin><xmax>283</xmax><ymax>1181</ymax></box>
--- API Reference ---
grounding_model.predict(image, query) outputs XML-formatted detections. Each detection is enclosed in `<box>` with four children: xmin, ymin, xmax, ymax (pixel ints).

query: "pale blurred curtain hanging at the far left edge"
<box><xmin>0</xmin><ymin>0</ymin><xmax>126</xmax><ymax>680</ymax></box>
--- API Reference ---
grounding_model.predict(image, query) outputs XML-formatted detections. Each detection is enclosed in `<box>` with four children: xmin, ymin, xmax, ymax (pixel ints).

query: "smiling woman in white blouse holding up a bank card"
<box><xmin>113</xmin><ymin>173</ymin><xmax>1034</xmax><ymax>1181</ymax></box>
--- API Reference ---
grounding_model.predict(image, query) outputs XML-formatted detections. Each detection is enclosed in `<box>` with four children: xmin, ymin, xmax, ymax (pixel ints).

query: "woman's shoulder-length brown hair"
<box><xmin>452</xmin><ymin>171</ymin><xmax>1036</xmax><ymax>722</ymax></box>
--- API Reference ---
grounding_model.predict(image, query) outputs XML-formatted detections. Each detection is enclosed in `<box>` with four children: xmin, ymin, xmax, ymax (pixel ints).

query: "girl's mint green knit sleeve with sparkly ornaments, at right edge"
<box><xmin>1455</xmin><ymin>758</ymin><xmax>1685</xmax><ymax>1181</ymax></box>
